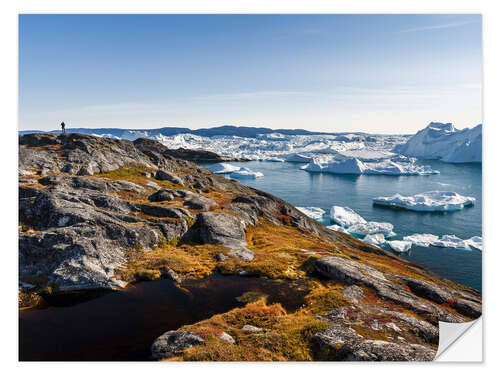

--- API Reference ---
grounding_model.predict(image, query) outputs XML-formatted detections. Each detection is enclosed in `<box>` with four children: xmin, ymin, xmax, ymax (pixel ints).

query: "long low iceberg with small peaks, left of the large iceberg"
<box><xmin>302</xmin><ymin>158</ymin><xmax>439</xmax><ymax>176</ymax></box>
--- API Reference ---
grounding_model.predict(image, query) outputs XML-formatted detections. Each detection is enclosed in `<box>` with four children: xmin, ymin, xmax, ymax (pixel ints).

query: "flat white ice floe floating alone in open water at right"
<box><xmin>373</xmin><ymin>191</ymin><xmax>476</xmax><ymax>211</ymax></box>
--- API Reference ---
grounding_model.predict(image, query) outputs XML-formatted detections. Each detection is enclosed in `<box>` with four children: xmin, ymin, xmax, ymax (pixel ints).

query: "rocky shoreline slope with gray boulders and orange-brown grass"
<box><xmin>19</xmin><ymin>133</ymin><xmax>481</xmax><ymax>361</ymax></box>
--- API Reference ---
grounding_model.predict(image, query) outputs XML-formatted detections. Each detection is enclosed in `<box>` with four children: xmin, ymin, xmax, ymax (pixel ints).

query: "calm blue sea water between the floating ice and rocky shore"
<box><xmin>204</xmin><ymin>160</ymin><xmax>482</xmax><ymax>291</ymax></box>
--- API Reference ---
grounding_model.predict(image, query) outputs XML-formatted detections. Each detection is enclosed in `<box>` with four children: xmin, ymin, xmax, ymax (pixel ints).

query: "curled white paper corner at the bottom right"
<box><xmin>434</xmin><ymin>316</ymin><xmax>483</xmax><ymax>362</ymax></box>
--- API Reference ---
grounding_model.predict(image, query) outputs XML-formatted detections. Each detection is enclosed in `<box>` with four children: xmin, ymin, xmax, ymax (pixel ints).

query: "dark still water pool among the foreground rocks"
<box><xmin>19</xmin><ymin>275</ymin><xmax>307</xmax><ymax>361</ymax></box>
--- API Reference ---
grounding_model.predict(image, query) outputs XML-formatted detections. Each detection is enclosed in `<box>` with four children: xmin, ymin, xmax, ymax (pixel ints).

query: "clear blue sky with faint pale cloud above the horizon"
<box><xmin>19</xmin><ymin>14</ymin><xmax>482</xmax><ymax>133</ymax></box>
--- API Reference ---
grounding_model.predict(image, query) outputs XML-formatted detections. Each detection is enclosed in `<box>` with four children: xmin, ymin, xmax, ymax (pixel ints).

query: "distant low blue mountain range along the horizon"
<box><xmin>19</xmin><ymin>125</ymin><xmax>376</xmax><ymax>139</ymax></box>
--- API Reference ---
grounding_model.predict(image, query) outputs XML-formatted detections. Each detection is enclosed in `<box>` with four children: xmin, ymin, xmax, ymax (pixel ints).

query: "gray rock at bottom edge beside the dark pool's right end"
<box><xmin>151</xmin><ymin>331</ymin><xmax>205</xmax><ymax>360</ymax></box>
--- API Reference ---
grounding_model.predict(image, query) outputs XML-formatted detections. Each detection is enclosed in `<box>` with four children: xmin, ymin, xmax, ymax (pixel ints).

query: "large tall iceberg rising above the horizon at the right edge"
<box><xmin>393</xmin><ymin>122</ymin><xmax>482</xmax><ymax>163</ymax></box>
